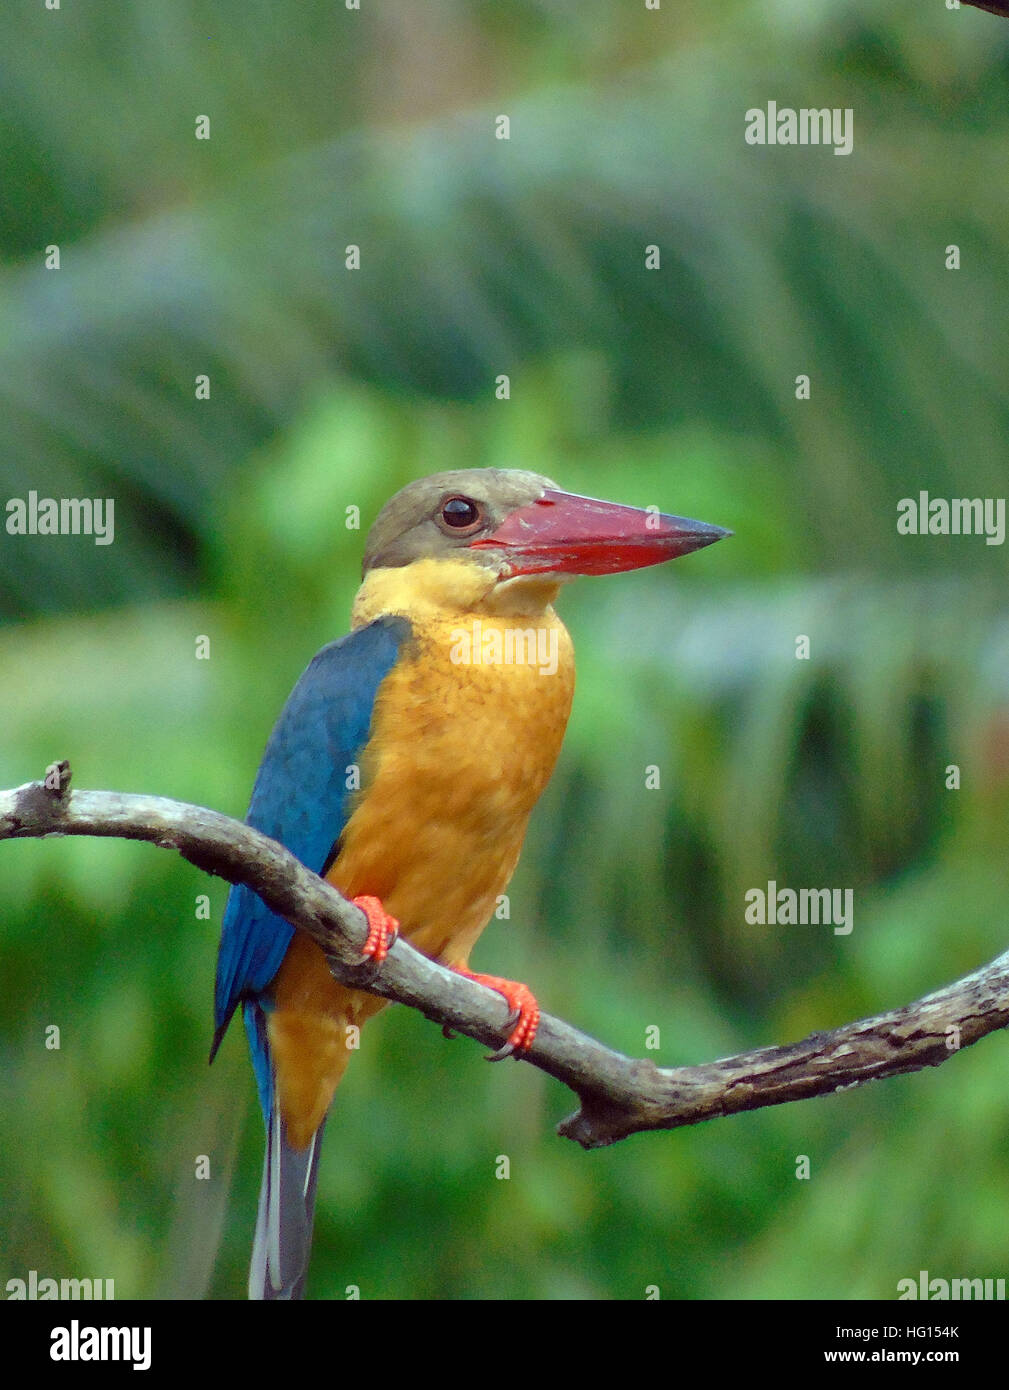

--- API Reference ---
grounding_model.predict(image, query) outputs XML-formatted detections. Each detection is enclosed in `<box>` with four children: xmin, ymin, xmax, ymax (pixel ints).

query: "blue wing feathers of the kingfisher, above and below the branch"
<box><xmin>210</xmin><ymin>617</ymin><xmax>411</xmax><ymax>1078</ymax></box>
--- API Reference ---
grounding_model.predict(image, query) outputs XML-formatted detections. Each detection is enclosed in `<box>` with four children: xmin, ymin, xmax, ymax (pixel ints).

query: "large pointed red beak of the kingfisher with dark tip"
<box><xmin>471</xmin><ymin>488</ymin><xmax>732</xmax><ymax>577</ymax></box>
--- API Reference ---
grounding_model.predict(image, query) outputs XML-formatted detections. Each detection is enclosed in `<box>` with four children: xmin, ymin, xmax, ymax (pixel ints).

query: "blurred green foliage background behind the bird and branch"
<box><xmin>0</xmin><ymin>0</ymin><xmax>1009</xmax><ymax>1298</ymax></box>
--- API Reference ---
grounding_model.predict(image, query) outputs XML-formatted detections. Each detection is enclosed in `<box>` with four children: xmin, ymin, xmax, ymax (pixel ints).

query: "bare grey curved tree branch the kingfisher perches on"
<box><xmin>0</xmin><ymin>763</ymin><xmax>1009</xmax><ymax>1148</ymax></box>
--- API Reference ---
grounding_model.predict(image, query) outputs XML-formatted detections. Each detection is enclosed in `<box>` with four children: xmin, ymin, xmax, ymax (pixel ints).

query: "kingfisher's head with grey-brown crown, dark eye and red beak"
<box><xmin>364</xmin><ymin>468</ymin><xmax>731</xmax><ymax>608</ymax></box>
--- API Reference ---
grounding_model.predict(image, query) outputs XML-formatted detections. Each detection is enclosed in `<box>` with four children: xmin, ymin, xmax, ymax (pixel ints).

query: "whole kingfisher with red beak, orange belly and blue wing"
<box><xmin>210</xmin><ymin>468</ymin><xmax>731</xmax><ymax>1300</ymax></box>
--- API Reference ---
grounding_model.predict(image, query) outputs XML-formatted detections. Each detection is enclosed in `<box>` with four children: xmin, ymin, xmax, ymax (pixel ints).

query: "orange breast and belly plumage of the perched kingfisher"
<box><xmin>268</xmin><ymin>612</ymin><xmax>574</xmax><ymax>1148</ymax></box>
